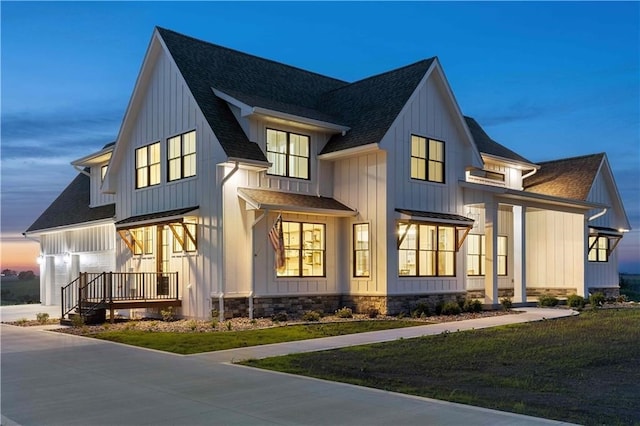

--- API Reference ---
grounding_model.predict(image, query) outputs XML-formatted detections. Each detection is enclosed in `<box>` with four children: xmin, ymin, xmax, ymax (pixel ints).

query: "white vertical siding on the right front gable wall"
<box><xmin>381</xmin><ymin>72</ymin><xmax>472</xmax><ymax>294</ymax></box>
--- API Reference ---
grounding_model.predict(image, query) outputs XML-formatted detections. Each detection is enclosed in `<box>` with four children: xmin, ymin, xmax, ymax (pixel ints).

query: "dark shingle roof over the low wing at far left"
<box><xmin>27</xmin><ymin>173</ymin><xmax>116</xmax><ymax>232</ymax></box>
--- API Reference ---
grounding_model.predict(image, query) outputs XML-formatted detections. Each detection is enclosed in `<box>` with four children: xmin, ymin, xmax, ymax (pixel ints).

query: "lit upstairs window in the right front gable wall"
<box><xmin>411</xmin><ymin>135</ymin><xmax>444</xmax><ymax>183</ymax></box>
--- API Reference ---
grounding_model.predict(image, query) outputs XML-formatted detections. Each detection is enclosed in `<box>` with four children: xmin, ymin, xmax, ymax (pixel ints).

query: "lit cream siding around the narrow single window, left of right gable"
<box><xmin>334</xmin><ymin>151</ymin><xmax>387</xmax><ymax>295</ymax></box>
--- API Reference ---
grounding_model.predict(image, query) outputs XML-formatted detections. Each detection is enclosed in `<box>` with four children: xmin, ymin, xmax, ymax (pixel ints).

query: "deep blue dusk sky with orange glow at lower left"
<box><xmin>0</xmin><ymin>1</ymin><xmax>640</xmax><ymax>273</ymax></box>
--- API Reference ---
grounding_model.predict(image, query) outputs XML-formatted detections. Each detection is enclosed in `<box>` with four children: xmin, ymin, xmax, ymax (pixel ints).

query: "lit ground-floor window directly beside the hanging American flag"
<box><xmin>278</xmin><ymin>222</ymin><xmax>325</xmax><ymax>277</ymax></box>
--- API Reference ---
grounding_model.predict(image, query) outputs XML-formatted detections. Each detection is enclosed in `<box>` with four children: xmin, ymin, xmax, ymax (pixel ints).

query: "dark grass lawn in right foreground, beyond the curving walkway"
<box><xmin>242</xmin><ymin>308</ymin><xmax>640</xmax><ymax>425</ymax></box>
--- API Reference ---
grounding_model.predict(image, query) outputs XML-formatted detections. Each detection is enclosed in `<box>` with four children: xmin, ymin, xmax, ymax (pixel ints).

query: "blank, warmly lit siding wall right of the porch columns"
<box><xmin>525</xmin><ymin>208</ymin><xmax>585</xmax><ymax>289</ymax></box>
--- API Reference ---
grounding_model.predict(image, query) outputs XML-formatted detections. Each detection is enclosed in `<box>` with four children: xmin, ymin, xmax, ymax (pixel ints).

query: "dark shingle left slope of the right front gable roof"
<box><xmin>318</xmin><ymin>58</ymin><xmax>435</xmax><ymax>154</ymax></box>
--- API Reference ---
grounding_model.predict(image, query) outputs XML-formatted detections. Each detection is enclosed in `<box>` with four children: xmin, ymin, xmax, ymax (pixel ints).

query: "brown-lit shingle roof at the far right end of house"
<box><xmin>524</xmin><ymin>153</ymin><xmax>605</xmax><ymax>201</ymax></box>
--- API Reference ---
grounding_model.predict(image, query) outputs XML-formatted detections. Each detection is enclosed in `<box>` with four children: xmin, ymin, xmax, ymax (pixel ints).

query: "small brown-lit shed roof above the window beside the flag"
<box><xmin>238</xmin><ymin>188</ymin><xmax>358</xmax><ymax>217</ymax></box>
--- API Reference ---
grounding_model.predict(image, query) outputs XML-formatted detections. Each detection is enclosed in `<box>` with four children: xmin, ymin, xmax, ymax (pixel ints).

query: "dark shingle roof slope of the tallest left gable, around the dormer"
<box><xmin>157</xmin><ymin>28</ymin><xmax>346</xmax><ymax>161</ymax></box>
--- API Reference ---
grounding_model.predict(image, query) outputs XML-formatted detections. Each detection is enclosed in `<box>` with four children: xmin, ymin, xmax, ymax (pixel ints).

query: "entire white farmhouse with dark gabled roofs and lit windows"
<box><xmin>26</xmin><ymin>28</ymin><xmax>630</xmax><ymax>318</ymax></box>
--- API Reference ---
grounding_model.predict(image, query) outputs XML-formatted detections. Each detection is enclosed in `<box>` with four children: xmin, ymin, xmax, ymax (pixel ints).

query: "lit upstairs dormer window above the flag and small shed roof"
<box><xmin>267</xmin><ymin>129</ymin><xmax>309</xmax><ymax>179</ymax></box>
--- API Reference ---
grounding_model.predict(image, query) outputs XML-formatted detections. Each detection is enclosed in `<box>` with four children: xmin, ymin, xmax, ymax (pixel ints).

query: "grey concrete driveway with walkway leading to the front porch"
<box><xmin>0</xmin><ymin>309</ymin><xmax>572</xmax><ymax>425</ymax></box>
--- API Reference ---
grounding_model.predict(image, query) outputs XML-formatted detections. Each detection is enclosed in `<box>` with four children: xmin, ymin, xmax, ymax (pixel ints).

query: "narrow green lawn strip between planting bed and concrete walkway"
<box><xmin>93</xmin><ymin>320</ymin><xmax>425</xmax><ymax>355</ymax></box>
